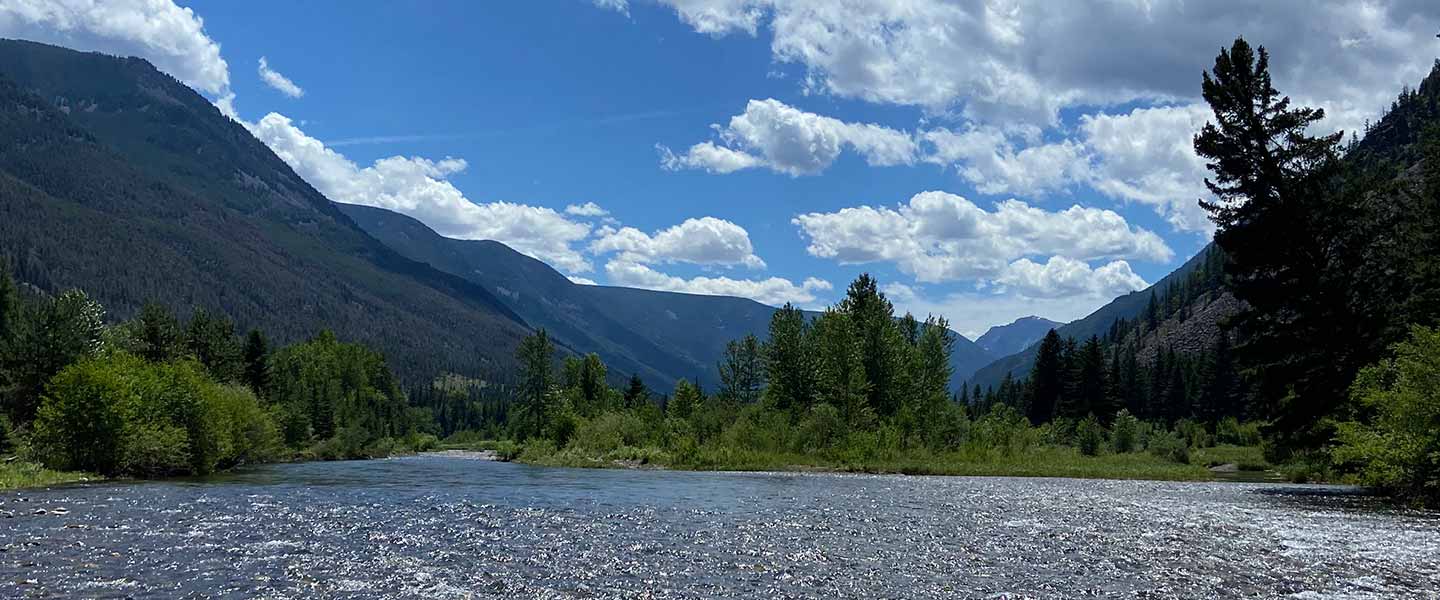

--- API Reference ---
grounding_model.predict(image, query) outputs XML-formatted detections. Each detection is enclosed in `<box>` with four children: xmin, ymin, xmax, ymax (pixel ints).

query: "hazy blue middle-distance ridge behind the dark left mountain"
<box><xmin>337</xmin><ymin>204</ymin><xmax>994</xmax><ymax>390</ymax></box>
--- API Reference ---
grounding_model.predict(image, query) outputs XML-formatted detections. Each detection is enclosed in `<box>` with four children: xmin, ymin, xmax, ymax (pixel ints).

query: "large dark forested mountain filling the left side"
<box><xmin>0</xmin><ymin>40</ymin><xmax>528</xmax><ymax>377</ymax></box>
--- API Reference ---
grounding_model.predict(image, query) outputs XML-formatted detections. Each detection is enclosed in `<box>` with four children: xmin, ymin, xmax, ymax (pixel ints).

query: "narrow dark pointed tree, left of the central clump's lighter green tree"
<box><xmin>763</xmin><ymin>302</ymin><xmax>815</xmax><ymax>414</ymax></box>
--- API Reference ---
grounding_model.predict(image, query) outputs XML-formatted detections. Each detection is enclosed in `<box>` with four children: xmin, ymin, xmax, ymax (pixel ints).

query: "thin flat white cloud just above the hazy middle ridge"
<box><xmin>605</xmin><ymin>258</ymin><xmax>831</xmax><ymax>306</ymax></box>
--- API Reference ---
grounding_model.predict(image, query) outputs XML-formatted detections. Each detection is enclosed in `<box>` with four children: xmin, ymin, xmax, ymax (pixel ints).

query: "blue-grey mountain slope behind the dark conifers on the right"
<box><xmin>969</xmin><ymin>243</ymin><xmax>1214</xmax><ymax>387</ymax></box>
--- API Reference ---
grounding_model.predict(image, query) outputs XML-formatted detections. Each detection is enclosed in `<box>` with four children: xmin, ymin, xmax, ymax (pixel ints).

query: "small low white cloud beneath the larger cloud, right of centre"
<box><xmin>995</xmin><ymin>256</ymin><xmax>1149</xmax><ymax>298</ymax></box>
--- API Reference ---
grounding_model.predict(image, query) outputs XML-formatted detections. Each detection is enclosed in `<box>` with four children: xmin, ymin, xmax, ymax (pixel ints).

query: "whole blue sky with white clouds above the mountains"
<box><xmin>0</xmin><ymin>0</ymin><xmax>1440</xmax><ymax>338</ymax></box>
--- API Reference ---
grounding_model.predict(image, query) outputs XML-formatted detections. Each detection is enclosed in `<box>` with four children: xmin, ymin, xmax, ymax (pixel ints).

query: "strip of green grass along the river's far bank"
<box><xmin>520</xmin><ymin>445</ymin><xmax>1214</xmax><ymax>481</ymax></box>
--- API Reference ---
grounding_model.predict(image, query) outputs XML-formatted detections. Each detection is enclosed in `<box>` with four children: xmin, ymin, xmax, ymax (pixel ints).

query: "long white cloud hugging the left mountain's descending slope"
<box><xmin>248</xmin><ymin>112</ymin><xmax>592</xmax><ymax>273</ymax></box>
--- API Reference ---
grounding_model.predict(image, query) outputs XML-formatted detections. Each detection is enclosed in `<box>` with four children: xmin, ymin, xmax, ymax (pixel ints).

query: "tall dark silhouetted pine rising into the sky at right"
<box><xmin>1194</xmin><ymin>39</ymin><xmax>1347</xmax><ymax>447</ymax></box>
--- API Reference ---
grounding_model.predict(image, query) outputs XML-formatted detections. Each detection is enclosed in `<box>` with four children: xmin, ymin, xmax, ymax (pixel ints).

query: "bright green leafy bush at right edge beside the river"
<box><xmin>1333</xmin><ymin>327</ymin><xmax>1440</xmax><ymax>502</ymax></box>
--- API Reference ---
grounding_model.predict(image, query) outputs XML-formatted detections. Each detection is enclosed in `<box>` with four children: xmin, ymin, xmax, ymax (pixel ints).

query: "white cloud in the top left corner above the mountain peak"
<box><xmin>0</xmin><ymin>0</ymin><xmax>230</xmax><ymax>96</ymax></box>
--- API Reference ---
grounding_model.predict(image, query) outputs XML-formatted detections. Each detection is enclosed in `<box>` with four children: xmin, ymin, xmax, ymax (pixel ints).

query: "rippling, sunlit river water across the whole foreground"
<box><xmin>0</xmin><ymin>456</ymin><xmax>1440</xmax><ymax>599</ymax></box>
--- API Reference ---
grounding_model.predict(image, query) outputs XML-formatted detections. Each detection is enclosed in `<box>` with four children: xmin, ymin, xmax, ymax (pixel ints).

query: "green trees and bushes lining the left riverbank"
<box><xmin>0</xmin><ymin>260</ymin><xmax>426</xmax><ymax>476</ymax></box>
